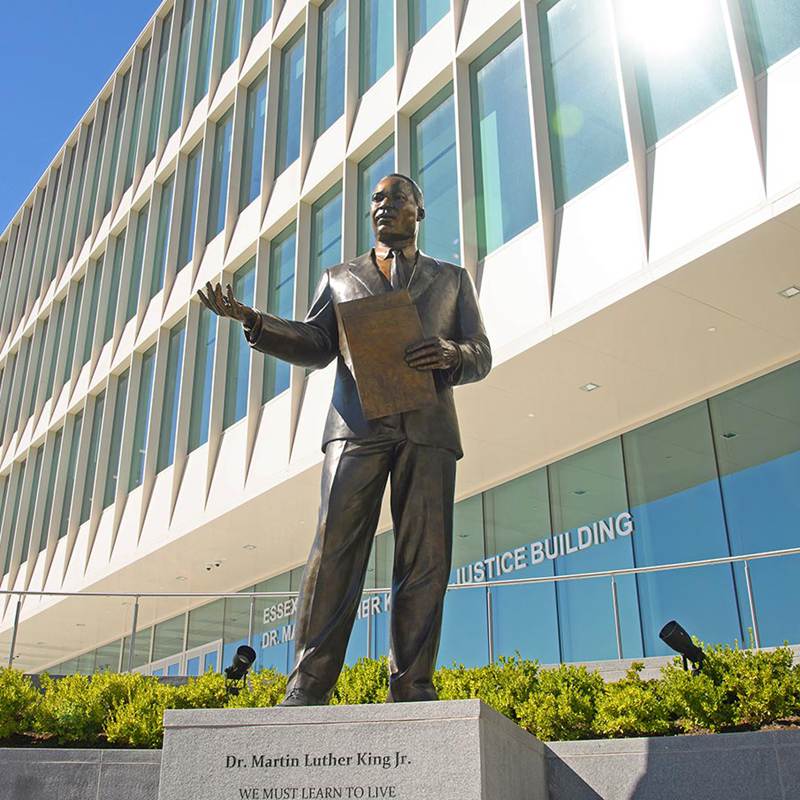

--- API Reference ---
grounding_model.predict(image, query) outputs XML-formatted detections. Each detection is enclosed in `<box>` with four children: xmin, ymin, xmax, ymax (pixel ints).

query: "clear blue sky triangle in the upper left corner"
<box><xmin>0</xmin><ymin>0</ymin><xmax>159</xmax><ymax>232</ymax></box>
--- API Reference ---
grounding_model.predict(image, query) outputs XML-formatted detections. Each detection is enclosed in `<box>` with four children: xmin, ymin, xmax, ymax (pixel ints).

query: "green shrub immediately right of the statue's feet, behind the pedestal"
<box><xmin>433</xmin><ymin>654</ymin><xmax>539</xmax><ymax>722</ymax></box>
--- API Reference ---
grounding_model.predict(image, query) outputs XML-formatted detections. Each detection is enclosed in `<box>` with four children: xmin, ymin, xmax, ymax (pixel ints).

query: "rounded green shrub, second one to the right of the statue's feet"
<box><xmin>519</xmin><ymin>664</ymin><xmax>604</xmax><ymax>741</ymax></box>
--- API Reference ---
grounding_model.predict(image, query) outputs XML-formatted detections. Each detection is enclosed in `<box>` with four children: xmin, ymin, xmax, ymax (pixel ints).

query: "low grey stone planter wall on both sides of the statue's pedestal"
<box><xmin>0</xmin><ymin>731</ymin><xmax>800</xmax><ymax>800</ymax></box>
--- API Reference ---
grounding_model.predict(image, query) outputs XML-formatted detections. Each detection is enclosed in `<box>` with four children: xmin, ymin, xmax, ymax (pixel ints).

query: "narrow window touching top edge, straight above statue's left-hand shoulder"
<box><xmin>314</xmin><ymin>0</ymin><xmax>347</xmax><ymax>136</ymax></box>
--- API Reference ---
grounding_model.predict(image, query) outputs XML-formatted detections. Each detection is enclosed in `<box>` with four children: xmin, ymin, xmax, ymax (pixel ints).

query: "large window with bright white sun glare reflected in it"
<box><xmin>619</xmin><ymin>0</ymin><xmax>736</xmax><ymax>147</ymax></box>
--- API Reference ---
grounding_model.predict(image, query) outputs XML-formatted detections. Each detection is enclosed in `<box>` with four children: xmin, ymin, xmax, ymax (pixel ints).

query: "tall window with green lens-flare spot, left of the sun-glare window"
<box><xmin>539</xmin><ymin>0</ymin><xmax>628</xmax><ymax>206</ymax></box>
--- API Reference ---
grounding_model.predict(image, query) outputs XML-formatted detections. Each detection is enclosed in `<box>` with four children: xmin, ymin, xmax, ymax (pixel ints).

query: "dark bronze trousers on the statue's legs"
<box><xmin>287</xmin><ymin>439</ymin><xmax>456</xmax><ymax>702</ymax></box>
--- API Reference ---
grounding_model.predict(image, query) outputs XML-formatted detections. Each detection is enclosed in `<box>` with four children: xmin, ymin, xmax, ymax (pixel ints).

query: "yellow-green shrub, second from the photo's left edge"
<box><xmin>33</xmin><ymin>672</ymin><xmax>144</xmax><ymax>744</ymax></box>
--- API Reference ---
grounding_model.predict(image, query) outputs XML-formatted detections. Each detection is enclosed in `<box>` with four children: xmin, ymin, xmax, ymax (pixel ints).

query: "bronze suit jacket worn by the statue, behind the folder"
<box><xmin>245</xmin><ymin>252</ymin><xmax>492</xmax><ymax>458</ymax></box>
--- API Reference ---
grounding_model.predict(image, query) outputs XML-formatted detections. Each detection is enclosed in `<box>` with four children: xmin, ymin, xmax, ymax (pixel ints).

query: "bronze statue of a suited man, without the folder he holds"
<box><xmin>198</xmin><ymin>174</ymin><xmax>492</xmax><ymax>706</ymax></box>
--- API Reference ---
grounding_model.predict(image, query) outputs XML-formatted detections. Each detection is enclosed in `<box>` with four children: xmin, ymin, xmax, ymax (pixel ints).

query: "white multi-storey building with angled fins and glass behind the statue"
<box><xmin>0</xmin><ymin>0</ymin><xmax>800</xmax><ymax>675</ymax></box>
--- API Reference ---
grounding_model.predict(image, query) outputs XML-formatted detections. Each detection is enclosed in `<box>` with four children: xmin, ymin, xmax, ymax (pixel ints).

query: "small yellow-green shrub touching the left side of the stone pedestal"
<box><xmin>104</xmin><ymin>678</ymin><xmax>176</xmax><ymax>748</ymax></box>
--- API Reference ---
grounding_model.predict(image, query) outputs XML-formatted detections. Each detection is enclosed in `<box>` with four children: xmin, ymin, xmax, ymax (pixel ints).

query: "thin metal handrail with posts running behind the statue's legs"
<box><xmin>6</xmin><ymin>547</ymin><xmax>800</xmax><ymax>670</ymax></box>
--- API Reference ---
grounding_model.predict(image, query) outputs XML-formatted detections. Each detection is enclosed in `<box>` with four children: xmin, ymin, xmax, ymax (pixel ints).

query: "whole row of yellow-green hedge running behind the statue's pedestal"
<box><xmin>0</xmin><ymin>646</ymin><xmax>800</xmax><ymax>748</ymax></box>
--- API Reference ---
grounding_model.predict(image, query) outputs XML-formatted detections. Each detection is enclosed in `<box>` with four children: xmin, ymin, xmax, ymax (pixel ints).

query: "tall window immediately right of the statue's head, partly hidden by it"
<box><xmin>411</xmin><ymin>87</ymin><xmax>461</xmax><ymax>264</ymax></box>
